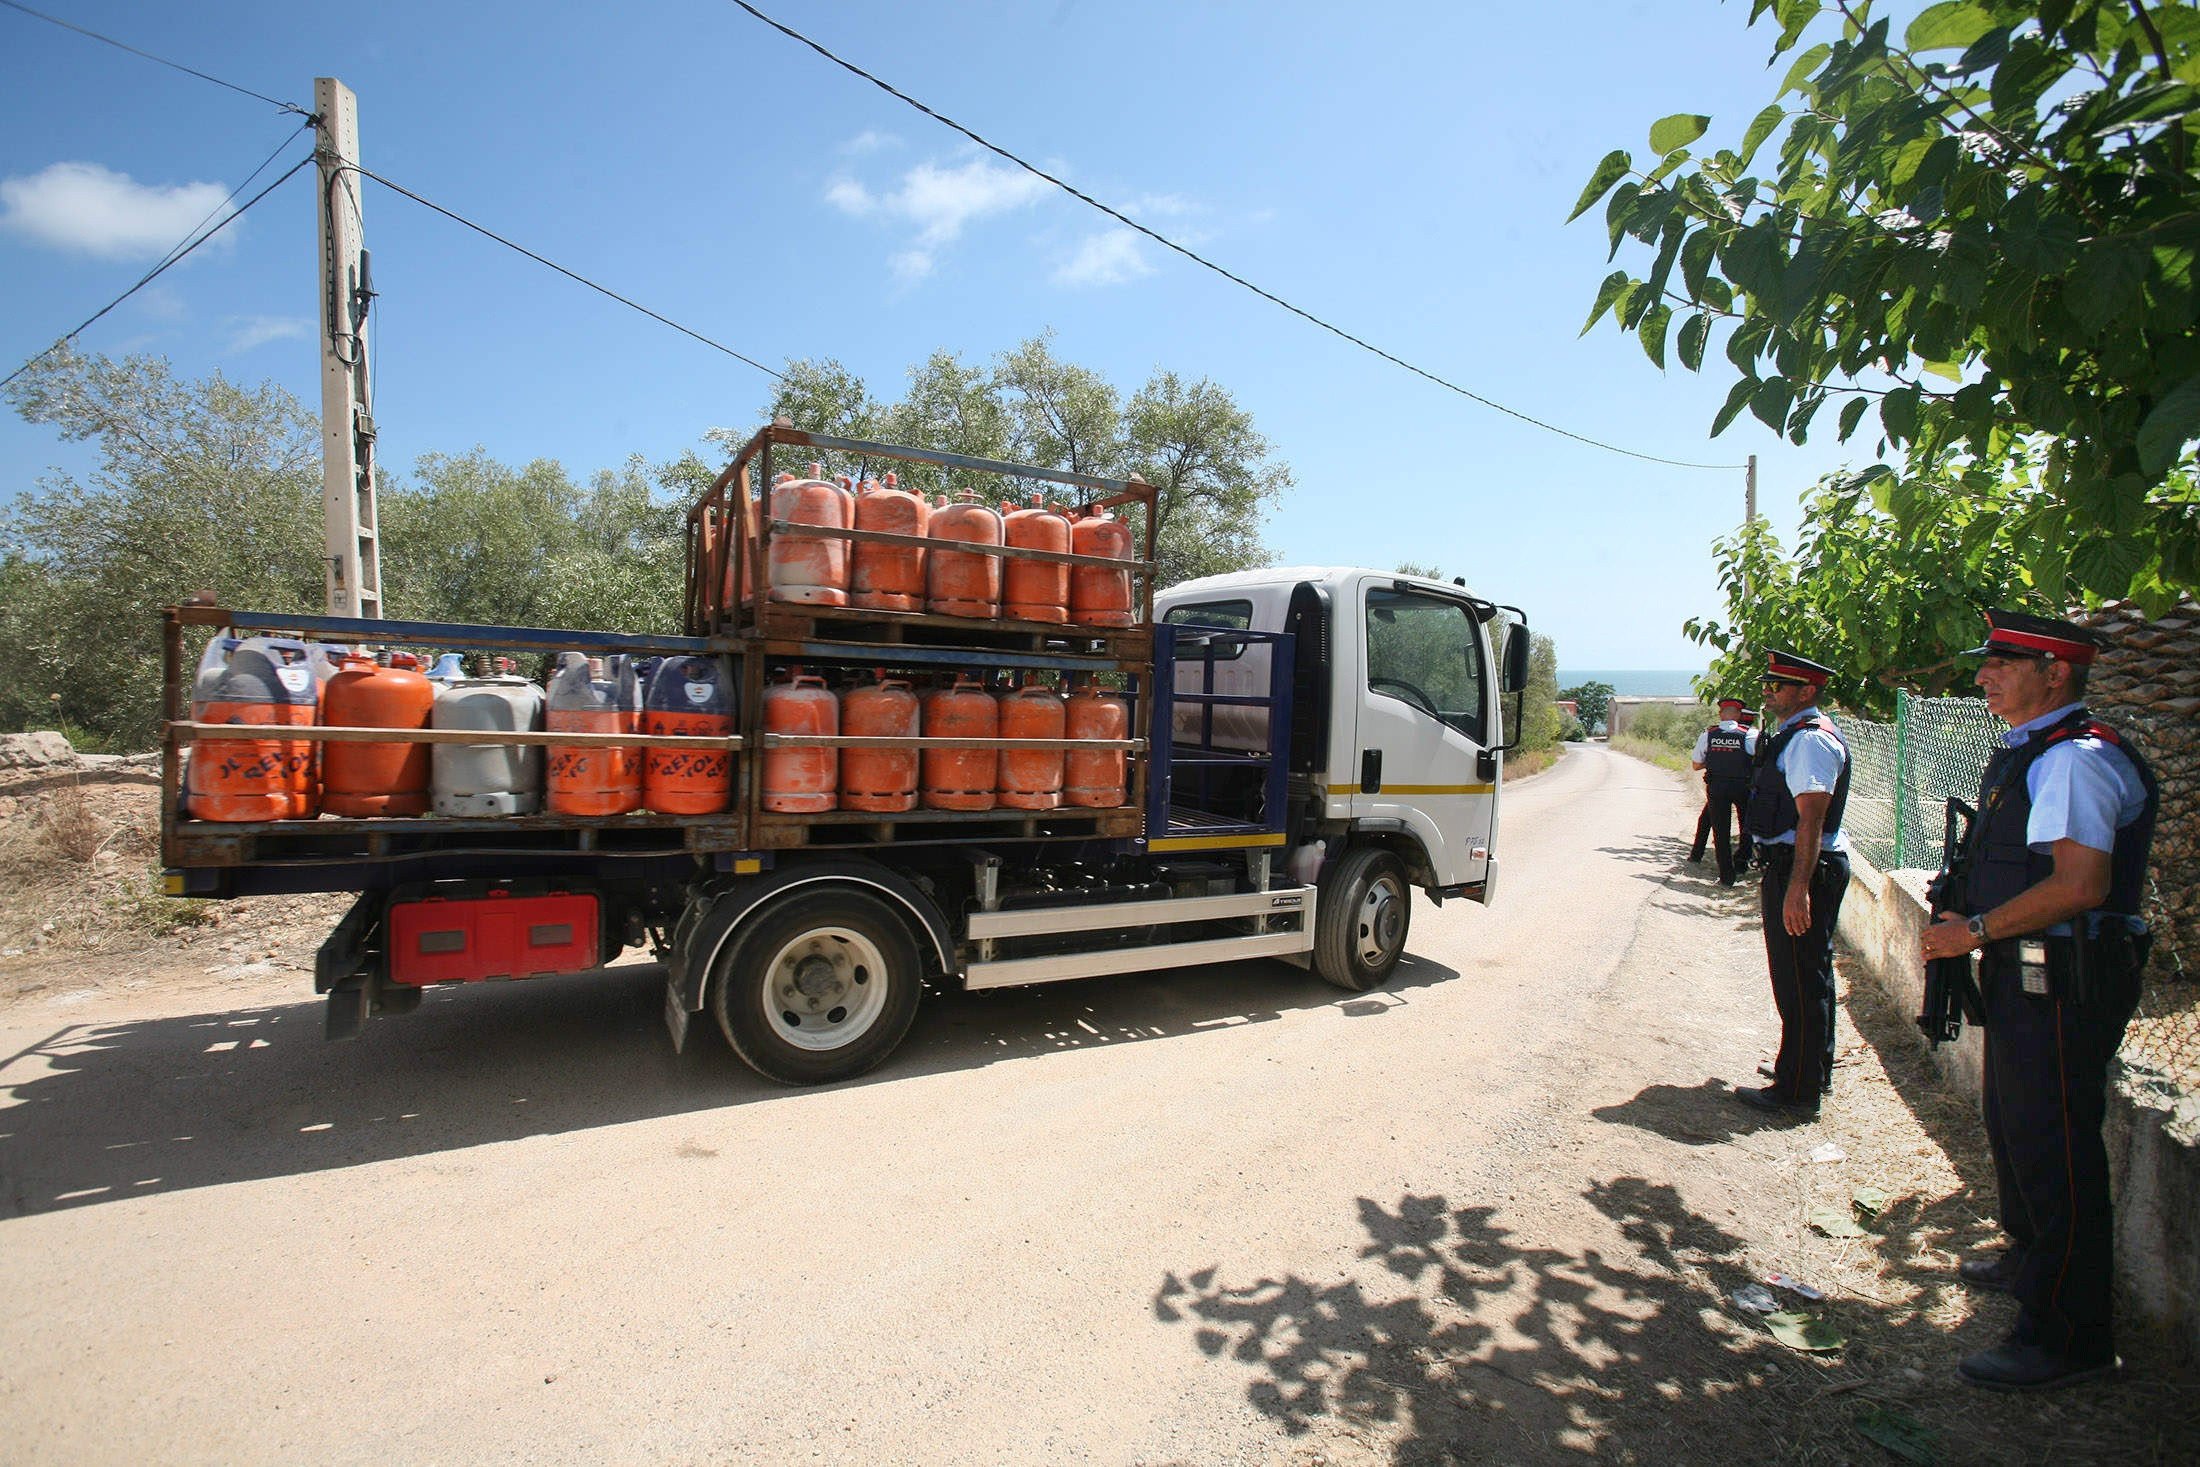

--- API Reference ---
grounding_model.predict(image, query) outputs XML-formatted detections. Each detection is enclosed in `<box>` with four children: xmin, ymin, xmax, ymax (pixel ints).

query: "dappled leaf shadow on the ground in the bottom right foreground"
<box><xmin>1153</xmin><ymin>1177</ymin><xmax>2200</xmax><ymax>1463</ymax></box>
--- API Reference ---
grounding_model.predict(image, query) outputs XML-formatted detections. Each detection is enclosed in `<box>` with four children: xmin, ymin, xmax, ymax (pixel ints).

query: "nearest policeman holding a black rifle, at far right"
<box><xmin>1923</xmin><ymin>611</ymin><xmax>2158</xmax><ymax>1390</ymax></box>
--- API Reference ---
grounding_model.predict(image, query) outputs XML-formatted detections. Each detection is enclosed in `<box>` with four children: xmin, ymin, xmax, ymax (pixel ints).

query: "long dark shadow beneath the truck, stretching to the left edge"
<box><xmin>0</xmin><ymin>957</ymin><xmax>1459</xmax><ymax>1218</ymax></box>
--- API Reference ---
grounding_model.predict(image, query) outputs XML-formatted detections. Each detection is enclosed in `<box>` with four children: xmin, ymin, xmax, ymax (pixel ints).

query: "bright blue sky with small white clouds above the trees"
<box><xmin>0</xmin><ymin>0</ymin><xmax>1892</xmax><ymax>669</ymax></box>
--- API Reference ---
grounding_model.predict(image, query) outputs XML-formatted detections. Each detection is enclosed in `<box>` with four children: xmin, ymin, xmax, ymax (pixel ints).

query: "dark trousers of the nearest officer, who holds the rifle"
<box><xmin>1980</xmin><ymin>958</ymin><xmax>2138</xmax><ymax>1361</ymax></box>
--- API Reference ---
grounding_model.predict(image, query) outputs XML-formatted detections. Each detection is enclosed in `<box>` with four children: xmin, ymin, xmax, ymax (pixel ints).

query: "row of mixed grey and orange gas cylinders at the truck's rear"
<box><xmin>185</xmin><ymin>638</ymin><xmax>735</xmax><ymax>823</ymax></box>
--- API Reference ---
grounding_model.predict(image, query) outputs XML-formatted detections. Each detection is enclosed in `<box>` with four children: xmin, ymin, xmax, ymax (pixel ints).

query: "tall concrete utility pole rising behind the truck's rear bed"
<box><xmin>312</xmin><ymin>77</ymin><xmax>383</xmax><ymax>616</ymax></box>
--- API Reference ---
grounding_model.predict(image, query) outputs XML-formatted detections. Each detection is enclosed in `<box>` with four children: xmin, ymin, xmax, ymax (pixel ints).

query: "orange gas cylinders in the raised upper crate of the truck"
<box><xmin>766</xmin><ymin>464</ymin><xmax>1137</xmax><ymax>627</ymax></box>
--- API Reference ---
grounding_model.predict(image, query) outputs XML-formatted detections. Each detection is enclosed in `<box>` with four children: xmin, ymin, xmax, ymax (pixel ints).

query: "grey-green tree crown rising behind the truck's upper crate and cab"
<box><xmin>765</xmin><ymin>332</ymin><xmax>1291</xmax><ymax>585</ymax></box>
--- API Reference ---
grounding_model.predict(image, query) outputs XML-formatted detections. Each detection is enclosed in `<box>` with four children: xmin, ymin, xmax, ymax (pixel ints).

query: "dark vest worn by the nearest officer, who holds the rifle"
<box><xmin>1962</xmin><ymin>708</ymin><xmax>2160</xmax><ymax>917</ymax></box>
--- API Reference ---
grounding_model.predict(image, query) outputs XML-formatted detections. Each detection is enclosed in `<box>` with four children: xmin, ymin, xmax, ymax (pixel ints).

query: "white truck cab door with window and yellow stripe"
<box><xmin>1340</xmin><ymin>581</ymin><xmax>1500</xmax><ymax>886</ymax></box>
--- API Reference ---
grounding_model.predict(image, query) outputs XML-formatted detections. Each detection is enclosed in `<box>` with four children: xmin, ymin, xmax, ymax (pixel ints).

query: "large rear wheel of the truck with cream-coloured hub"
<box><xmin>711</xmin><ymin>889</ymin><xmax>924</xmax><ymax>1084</ymax></box>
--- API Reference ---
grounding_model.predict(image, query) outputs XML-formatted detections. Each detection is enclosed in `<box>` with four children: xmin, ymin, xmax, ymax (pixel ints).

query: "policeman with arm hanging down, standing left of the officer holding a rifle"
<box><xmin>1734</xmin><ymin>651</ymin><xmax>1850</xmax><ymax>1117</ymax></box>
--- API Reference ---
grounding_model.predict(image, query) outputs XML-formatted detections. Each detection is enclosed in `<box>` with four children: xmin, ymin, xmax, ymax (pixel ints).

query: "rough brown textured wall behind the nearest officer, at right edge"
<box><xmin>2079</xmin><ymin>600</ymin><xmax>2200</xmax><ymax>981</ymax></box>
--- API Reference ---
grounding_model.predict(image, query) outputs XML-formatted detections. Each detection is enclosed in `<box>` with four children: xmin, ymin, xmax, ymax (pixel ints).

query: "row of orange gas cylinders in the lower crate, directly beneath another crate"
<box><xmin>761</xmin><ymin>666</ymin><xmax>1131</xmax><ymax>814</ymax></box>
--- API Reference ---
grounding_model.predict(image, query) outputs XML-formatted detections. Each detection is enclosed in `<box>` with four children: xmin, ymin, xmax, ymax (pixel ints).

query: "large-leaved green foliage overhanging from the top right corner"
<box><xmin>1575</xmin><ymin>0</ymin><xmax>2200</xmax><ymax>609</ymax></box>
